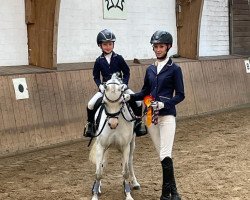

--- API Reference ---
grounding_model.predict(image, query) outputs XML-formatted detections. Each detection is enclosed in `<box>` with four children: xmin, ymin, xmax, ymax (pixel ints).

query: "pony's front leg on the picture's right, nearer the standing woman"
<box><xmin>122</xmin><ymin>145</ymin><xmax>134</xmax><ymax>200</ymax></box>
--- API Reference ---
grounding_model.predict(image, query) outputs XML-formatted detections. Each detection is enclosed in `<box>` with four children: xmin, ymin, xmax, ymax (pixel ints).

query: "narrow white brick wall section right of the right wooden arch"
<box><xmin>199</xmin><ymin>0</ymin><xmax>229</xmax><ymax>56</ymax></box>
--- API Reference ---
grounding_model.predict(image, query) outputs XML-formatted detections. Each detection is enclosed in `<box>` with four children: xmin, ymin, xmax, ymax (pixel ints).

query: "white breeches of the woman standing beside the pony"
<box><xmin>148</xmin><ymin>115</ymin><xmax>176</xmax><ymax>161</ymax></box>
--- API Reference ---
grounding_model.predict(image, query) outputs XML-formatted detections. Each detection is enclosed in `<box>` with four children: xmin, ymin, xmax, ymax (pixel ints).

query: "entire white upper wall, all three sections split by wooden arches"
<box><xmin>0</xmin><ymin>0</ymin><xmax>229</xmax><ymax>66</ymax></box>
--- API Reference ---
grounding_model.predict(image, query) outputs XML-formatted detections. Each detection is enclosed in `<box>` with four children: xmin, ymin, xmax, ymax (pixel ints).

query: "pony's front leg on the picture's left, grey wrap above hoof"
<box><xmin>92</xmin><ymin>145</ymin><xmax>104</xmax><ymax>200</ymax></box>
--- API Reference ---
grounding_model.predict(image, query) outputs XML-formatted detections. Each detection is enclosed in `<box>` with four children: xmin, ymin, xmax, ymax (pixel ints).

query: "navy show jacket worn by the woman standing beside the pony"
<box><xmin>131</xmin><ymin>58</ymin><xmax>185</xmax><ymax>116</ymax></box>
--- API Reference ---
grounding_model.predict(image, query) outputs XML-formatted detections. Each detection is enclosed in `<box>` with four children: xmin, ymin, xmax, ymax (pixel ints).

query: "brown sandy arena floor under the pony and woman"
<box><xmin>0</xmin><ymin>107</ymin><xmax>250</xmax><ymax>200</ymax></box>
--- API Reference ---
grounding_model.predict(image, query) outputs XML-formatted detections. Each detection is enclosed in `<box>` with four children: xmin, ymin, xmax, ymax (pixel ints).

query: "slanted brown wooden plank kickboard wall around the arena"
<box><xmin>0</xmin><ymin>59</ymin><xmax>250</xmax><ymax>156</ymax></box>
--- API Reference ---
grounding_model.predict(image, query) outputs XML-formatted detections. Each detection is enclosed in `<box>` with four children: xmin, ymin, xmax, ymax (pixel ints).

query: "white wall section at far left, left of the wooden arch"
<box><xmin>0</xmin><ymin>0</ymin><xmax>28</xmax><ymax>66</ymax></box>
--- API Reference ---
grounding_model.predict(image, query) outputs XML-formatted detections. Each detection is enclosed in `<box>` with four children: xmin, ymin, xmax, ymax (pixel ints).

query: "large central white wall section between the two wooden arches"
<box><xmin>57</xmin><ymin>0</ymin><xmax>177</xmax><ymax>63</ymax></box>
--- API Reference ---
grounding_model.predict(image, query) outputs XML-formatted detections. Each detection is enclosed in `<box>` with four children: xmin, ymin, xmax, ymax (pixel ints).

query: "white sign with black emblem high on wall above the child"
<box><xmin>103</xmin><ymin>0</ymin><xmax>127</xmax><ymax>19</ymax></box>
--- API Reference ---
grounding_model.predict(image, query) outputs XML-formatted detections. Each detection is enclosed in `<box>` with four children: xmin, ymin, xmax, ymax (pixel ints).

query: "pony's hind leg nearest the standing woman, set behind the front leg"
<box><xmin>129</xmin><ymin>136</ymin><xmax>141</xmax><ymax>190</ymax></box>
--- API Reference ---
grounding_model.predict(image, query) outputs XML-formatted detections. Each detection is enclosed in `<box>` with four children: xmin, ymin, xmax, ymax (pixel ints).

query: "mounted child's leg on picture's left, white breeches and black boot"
<box><xmin>85</xmin><ymin>92</ymin><xmax>102</xmax><ymax>137</ymax></box>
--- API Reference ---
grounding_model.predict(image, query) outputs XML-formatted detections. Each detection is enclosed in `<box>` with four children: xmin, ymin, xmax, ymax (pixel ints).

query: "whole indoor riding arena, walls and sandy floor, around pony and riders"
<box><xmin>0</xmin><ymin>0</ymin><xmax>250</xmax><ymax>200</ymax></box>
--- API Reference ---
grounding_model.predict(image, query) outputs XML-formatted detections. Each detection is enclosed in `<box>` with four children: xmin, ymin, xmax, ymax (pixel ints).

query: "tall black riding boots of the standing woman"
<box><xmin>160</xmin><ymin>157</ymin><xmax>181</xmax><ymax>200</ymax></box>
